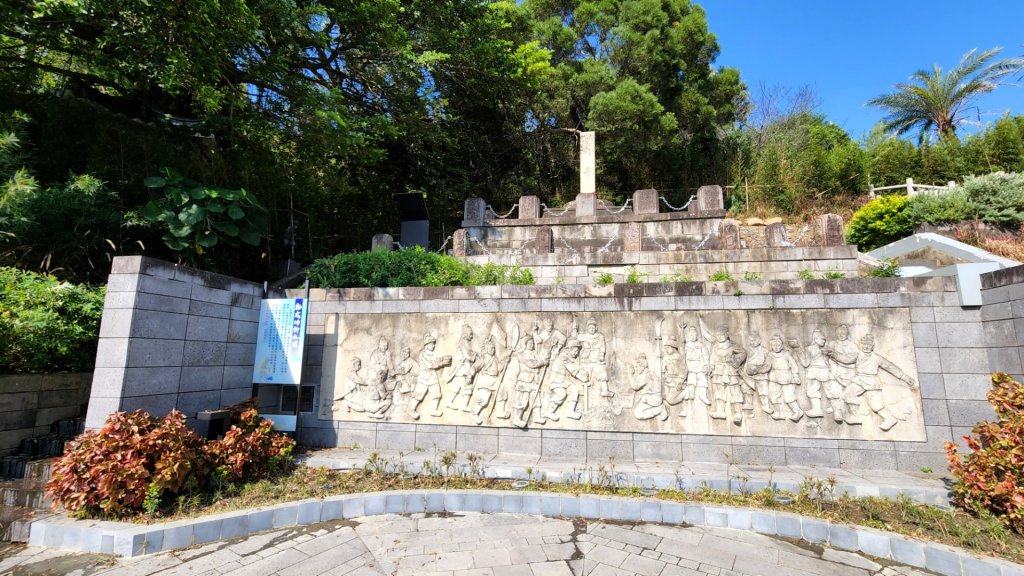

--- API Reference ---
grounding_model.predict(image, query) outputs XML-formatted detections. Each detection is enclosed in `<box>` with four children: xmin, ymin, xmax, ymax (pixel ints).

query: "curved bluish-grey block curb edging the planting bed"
<box><xmin>29</xmin><ymin>490</ymin><xmax>1024</xmax><ymax>576</ymax></box>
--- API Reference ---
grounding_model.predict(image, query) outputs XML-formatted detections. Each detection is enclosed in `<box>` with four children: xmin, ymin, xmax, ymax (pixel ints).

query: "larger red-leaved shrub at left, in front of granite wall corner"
<box><xmin>46</xmin><ymin>410</ymin><xmax>209</xmax><ymax>516</ymax></box>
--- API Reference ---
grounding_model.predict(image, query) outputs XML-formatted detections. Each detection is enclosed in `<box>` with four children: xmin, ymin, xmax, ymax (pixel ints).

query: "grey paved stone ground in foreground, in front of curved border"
<box><xmin>0</xmin><ymin>513</ymin><xmax>926</xmax><ymax>576</ymax></box>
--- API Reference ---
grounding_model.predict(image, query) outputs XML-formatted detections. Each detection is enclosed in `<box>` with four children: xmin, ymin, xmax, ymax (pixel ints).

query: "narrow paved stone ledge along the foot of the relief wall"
<box><xmin>299</xmin><ymin>448</ymin><xmax>950</xmax><ymax>506</ymax></box>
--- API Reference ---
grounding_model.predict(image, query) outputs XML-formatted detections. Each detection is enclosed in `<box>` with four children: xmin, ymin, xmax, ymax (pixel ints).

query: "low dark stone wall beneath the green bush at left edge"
<box><xmin>0</xmin><ymin>373</ymin><xmax>92</xmax><ymax>454</ymax></box>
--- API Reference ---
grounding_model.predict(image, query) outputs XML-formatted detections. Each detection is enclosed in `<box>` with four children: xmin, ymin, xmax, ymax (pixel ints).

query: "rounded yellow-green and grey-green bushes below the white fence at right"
<box><xmin>846</xmin><ymin>172</ymin><xmax>1024</xmax><ymax>250</ymax></box>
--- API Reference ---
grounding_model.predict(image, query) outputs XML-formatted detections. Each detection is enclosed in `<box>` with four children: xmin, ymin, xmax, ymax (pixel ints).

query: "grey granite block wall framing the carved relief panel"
<box><xmin>288</xmin><ymin>278</ymin><xmax>991</xmax><ymax>470</ymax></box>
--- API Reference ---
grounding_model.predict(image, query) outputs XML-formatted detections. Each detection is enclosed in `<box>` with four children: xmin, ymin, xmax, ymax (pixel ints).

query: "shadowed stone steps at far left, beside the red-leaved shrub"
<box><xmin>0</xmin><ymin>418</ymin><xmax>85</xmax><ymax>542</ymax></box>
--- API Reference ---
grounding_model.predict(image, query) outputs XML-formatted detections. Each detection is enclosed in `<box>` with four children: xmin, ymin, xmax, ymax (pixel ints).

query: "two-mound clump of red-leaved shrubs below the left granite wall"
<box><xmin>46</xmin><ymin>409</ymin><xmax>295</xmax><ymax>518</ymax></box>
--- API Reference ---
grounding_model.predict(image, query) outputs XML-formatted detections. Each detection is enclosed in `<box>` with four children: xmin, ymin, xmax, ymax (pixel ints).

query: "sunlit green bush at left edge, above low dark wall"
<box><xmin>0</xmin><ymin>266</ymin><xmax>103</xmax><ymax>373</ymax></box>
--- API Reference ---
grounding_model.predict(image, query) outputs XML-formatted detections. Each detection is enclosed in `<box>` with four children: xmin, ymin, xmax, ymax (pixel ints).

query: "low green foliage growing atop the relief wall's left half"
<box><xmin>305</xmin><ymin>248</ymin><xmax>534</xmax><ymax>288</ymax></box>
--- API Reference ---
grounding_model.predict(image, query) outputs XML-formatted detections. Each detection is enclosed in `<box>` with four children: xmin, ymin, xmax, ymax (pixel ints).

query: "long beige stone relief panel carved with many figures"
<box><xmin>318</xmin><ymin>308</ymin><xmax>927</xmax><ymax>442</ymax></box>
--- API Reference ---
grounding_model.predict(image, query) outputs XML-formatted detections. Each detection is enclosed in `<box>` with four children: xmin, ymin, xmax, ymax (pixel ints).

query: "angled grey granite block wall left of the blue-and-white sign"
<box><xmin>86</xmin><ymin>256</ymin><xmax>276</xmax><ymax>427</ymax></box>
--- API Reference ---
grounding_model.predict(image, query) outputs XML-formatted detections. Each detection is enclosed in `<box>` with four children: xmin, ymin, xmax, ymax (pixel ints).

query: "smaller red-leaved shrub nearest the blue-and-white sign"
<box><xmin>207</xmin><ymin>408</ymin><xmax>295</xmax><ymax>482</ymax></box>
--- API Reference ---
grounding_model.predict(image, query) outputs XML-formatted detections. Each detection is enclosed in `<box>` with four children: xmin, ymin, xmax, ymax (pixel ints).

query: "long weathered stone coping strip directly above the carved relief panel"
<box><xmin>286</xmin><ymin>277</ymin><xmax>956</xmax><ymax>301</ymax></box>
